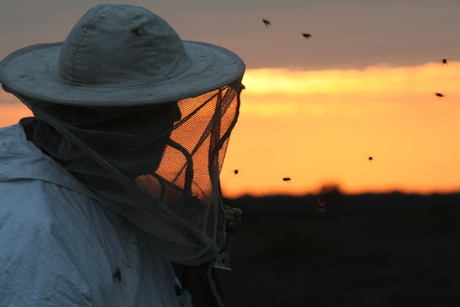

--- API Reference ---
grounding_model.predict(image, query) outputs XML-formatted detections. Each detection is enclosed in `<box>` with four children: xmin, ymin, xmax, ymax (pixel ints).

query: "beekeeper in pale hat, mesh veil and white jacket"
<box><xmin>0</xmin><ymin>5</ymin><xmax>245</xmax><ymax>306</ymax></box>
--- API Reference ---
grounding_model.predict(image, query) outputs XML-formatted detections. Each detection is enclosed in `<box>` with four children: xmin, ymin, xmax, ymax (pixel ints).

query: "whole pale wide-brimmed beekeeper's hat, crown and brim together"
<box><xmin>0</xmin><ymin>4</ymin><xmax>245</xmax><ymax>106</ymax></box>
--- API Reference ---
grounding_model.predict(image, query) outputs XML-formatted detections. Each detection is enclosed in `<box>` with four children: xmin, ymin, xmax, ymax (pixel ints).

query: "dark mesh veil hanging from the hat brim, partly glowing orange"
<box><xmin>13</xmin><ymin>80</ymin><xmax>242</xmax><ymax>265</ymax></box>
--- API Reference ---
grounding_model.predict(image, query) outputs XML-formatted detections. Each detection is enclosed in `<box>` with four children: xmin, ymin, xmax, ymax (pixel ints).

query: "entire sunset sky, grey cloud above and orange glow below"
<box><xmin>0</xmin><ymin>0</ymin><xmax>460</xmax><ymax>197</ymax></box>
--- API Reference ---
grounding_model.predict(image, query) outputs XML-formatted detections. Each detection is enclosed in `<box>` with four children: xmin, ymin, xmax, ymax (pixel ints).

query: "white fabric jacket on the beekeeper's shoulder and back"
<box><xmin>0</xmin><ymin>125</ymin><xmax>191</xmax><ymax>307</ymax></box>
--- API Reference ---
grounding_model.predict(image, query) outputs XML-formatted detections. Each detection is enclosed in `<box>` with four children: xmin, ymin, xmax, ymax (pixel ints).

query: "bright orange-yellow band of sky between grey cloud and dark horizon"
<box><xmin>0</xmin><ymin>61</ymin><xmax>460</xmax><ymax>198</ymax></box>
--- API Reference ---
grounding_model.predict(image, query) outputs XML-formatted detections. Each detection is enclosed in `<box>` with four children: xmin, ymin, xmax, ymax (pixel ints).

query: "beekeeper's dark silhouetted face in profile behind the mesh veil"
<box><xmin>54</xmin><ymin>102</ymin><xmax>181</xmax><ymax>179</ymax></box>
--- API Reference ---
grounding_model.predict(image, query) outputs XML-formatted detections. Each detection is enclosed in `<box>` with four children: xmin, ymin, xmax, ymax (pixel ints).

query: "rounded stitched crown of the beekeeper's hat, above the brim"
<box><xmin>57</xmin><ymin>5</ymin><xmax>191</xmax><ymax>87</ymax></box>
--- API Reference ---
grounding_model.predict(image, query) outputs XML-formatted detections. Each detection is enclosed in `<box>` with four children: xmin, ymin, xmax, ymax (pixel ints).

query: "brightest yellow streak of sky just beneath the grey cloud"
<box><xmin>243</xmin><ymin>62</ymin><xmax>460</xmax><ymax>95</ymax></box>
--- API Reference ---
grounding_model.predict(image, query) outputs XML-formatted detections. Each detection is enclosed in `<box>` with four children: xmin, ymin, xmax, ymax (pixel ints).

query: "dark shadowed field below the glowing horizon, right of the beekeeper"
<box><xmin>189</xmin><ymin>190</ymin><xmax>460</xmax><ymax>307</ymax></box>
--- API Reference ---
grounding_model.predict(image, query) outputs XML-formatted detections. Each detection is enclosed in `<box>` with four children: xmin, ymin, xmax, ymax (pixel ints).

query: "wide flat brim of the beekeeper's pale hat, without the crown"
<box><xmin>0</xmin><ymin>41</ymin><xmax>245</xmax><ymax>106</ymax></box>
